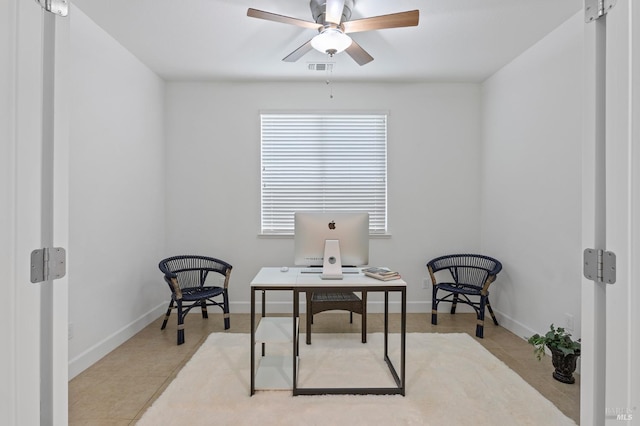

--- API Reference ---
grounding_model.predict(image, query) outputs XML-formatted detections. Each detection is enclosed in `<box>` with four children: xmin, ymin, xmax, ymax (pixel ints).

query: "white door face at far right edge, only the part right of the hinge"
<box><xmin>605</xmin><ymin>0</ymin><xmax>640</xmax><ymax>424</ymax></box>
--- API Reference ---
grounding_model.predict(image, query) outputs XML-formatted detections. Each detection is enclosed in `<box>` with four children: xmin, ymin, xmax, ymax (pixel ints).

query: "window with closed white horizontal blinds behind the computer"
<box><xmin>261</xmin><ymin>113</ymin><xmax>387</xmax><ymax>235</ymax></box>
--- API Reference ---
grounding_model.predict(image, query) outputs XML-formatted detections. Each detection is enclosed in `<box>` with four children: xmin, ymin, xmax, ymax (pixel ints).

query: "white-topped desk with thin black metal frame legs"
<box><xmin>250</xmin><ymin>268</ymin><xmax>407</xmax><ymax>396</ymax></box>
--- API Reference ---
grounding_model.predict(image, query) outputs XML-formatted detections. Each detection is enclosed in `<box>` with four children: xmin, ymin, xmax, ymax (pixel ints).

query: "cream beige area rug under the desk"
<box><xmin>137</xmin><ymin>333</ymin><xmax>575</xmax><ymax>426</ymax></box>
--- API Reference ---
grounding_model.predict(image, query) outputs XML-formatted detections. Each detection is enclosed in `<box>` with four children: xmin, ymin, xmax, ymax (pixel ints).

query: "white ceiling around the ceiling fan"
<box><xmin>71</xmin><ymin>0</ymin><xmax>582</xmax><ymax>82</ymax></box>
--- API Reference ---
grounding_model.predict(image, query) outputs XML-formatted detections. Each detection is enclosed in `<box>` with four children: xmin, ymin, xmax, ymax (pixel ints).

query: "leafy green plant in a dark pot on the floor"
<box><xmin>527</xmin><ymin>324</ymin><xmax>580</xmax><ymax>383</ymax></box>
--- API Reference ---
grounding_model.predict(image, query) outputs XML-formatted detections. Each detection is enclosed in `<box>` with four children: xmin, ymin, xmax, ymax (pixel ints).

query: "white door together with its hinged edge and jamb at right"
<box><xmin>580</xmin><ymin>0</ymin><xmax>640</xmax><ymax>425</ymax></box>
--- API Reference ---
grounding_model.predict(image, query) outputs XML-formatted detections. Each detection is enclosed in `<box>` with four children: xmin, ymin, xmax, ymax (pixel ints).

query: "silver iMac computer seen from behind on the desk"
<box><xmin>294</xmin><ymin>212</ymin><xmax>369</xmax><ymax>279</ymax></box>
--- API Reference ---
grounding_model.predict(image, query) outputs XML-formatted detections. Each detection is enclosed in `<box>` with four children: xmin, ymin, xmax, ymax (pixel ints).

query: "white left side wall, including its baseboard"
<box><xmin>69</xmin><ymin>8</ymin><xmax>167</xmax><ymax>377</ymax></box>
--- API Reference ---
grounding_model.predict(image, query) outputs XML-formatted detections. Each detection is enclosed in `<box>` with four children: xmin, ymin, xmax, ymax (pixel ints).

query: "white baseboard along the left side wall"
<box><xmin>69</xmin><ymin>302</ymin><xmax>167</xmax><ymax>380</ymax></box>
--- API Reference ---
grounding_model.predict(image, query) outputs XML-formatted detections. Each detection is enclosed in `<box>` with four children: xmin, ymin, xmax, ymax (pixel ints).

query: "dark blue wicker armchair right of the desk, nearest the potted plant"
<box><xmin>427</xmin><ymin>254</ymin><xmax>502</xmax><ymax>338</ymax></box>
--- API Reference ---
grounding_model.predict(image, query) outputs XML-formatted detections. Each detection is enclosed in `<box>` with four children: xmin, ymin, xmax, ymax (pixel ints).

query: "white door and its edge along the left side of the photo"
<box><xmin>0</xmin><ymin>0</ymin><xmax>68</xmax><ymax>425</ymax></box>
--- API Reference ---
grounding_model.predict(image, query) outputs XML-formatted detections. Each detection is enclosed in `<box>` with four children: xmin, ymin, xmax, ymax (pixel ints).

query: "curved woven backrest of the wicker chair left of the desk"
<box><xmin>158</xmin><ymin>255</ymin><xmax>233</xmax><ymax>291</ymax></box>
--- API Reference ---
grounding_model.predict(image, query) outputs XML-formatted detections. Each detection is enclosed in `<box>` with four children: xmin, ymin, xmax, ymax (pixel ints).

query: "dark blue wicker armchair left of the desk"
<box><xmin>158</xmin><ymin>255</ymin><xmax>232</xmax><ymax>345</ymax></box>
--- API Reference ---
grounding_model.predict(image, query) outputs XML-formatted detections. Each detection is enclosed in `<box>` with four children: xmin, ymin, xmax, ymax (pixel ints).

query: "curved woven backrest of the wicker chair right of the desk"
<box><xmin>427</xmin><ymin>254</ymin><xmax>502</xmax><ymax>288</ymax></box>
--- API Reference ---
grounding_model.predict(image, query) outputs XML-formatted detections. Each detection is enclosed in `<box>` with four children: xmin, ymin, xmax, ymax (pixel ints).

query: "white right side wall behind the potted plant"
<box><xmin>482</xmin><ymin>13</ymin><xmax>584</xmax><ymax>336</ymax></box>
